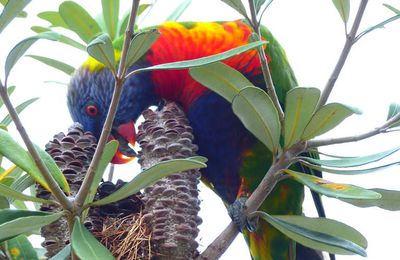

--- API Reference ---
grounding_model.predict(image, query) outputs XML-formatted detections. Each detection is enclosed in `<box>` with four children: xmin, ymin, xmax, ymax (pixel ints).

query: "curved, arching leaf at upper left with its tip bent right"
<box><xmin>4</xmin><ymin>32</ymin><xmax>59</xmax><ymax>81</ymax></box>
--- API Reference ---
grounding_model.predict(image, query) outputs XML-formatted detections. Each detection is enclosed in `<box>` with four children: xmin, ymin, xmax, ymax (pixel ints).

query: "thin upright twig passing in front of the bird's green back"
<box><xmin>249</xmin><ymin>0</ymin><xmax>284</xmax><ymax>123</ymax></box>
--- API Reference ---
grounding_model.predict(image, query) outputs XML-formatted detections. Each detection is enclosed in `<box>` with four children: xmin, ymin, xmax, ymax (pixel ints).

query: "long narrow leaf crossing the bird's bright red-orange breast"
<box><xmin>135</xmin><ymin>41</ymin><xmax>267</xmax><ymax>73</ymax></box>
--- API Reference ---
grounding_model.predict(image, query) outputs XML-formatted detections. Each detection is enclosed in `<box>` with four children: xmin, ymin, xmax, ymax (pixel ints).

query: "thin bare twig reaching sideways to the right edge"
<box><xmin>307</xmin><ymin>113</ymin><xmax>400</xmax><ymax>148</ymax></box>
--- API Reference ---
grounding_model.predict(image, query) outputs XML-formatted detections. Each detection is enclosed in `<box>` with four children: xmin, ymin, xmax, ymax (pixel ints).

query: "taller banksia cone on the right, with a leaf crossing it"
<box><xmin>137</xmin><ymin>103</ymin><xmax>201</xmax><ymax>259</ymax></box>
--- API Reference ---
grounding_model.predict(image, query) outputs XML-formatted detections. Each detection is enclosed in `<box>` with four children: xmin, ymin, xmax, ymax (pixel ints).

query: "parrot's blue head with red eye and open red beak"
<box><xmin>67</xmin><ymin>62</ymin><xmax>157</xmax><ymax>164</ymax></box>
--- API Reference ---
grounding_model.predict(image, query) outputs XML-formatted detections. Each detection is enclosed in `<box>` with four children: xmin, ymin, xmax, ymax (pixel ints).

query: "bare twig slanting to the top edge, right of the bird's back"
<box><xmin>317</xmin><ymin>0</ymin><xmax>368</xmax><ymax>109</ymax></box>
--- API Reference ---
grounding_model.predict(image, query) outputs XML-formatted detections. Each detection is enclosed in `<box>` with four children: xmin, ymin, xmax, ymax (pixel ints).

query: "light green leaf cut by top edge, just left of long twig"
<box><xmin>101</xmin><ymin>0</ymin><xmax>119</xmax><ymax>40</ymax></box>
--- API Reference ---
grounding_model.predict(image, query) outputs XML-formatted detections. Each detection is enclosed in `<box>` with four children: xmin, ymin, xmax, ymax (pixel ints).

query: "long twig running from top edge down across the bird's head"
<box><xmin>74</xmin><ymin>0</ymin><xmax>140</xmax><ymax>211</ymax></box>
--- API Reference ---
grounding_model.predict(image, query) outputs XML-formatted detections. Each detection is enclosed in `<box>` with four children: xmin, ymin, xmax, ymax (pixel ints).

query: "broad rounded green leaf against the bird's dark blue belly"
<box><xmin>232</xmin><ymin>87</ymin><xmax>281</xmax><ymax>154</ymax></box>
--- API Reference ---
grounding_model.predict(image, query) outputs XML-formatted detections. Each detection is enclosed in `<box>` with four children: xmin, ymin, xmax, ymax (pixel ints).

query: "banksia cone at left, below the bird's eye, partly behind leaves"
<box><xmin>36</xmin><ymin>124</ymin><xmax>97</xmax><ymax>257</ymax></box>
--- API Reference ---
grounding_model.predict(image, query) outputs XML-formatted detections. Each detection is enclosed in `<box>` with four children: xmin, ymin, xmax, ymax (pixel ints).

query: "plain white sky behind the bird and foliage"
<box><xmin>0</xmin><ymin>0</ymin><xmax>400</xmax><ymax>260</ymax></box>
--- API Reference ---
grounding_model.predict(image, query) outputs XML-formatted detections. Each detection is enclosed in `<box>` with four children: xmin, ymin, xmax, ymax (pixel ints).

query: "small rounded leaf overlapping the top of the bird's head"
<box><xmin>87</xmin><ymin>33</ymin><xmax>115</xmax><ymax>69</ymax></box>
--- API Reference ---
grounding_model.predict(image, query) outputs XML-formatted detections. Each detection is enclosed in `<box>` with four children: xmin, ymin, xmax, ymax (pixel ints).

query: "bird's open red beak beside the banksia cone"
<box><xmin>110</xmin><ymin>122</ymin><xmax>136</xmax><ymax>164</ymax></box>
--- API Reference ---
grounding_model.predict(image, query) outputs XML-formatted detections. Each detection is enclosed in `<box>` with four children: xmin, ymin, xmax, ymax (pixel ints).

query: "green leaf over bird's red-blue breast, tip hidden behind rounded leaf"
<box><xmin>189</xmin><ymin>62</ymin><xmax>253</xmax><ymax>103</ymax></box>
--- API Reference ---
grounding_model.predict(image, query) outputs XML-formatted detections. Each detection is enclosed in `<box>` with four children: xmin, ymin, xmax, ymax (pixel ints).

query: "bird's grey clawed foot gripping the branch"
<box><xmin>228</xmin><ymin>197</ymin><xmax>258</xmax><ymax>232</ymax></box>
